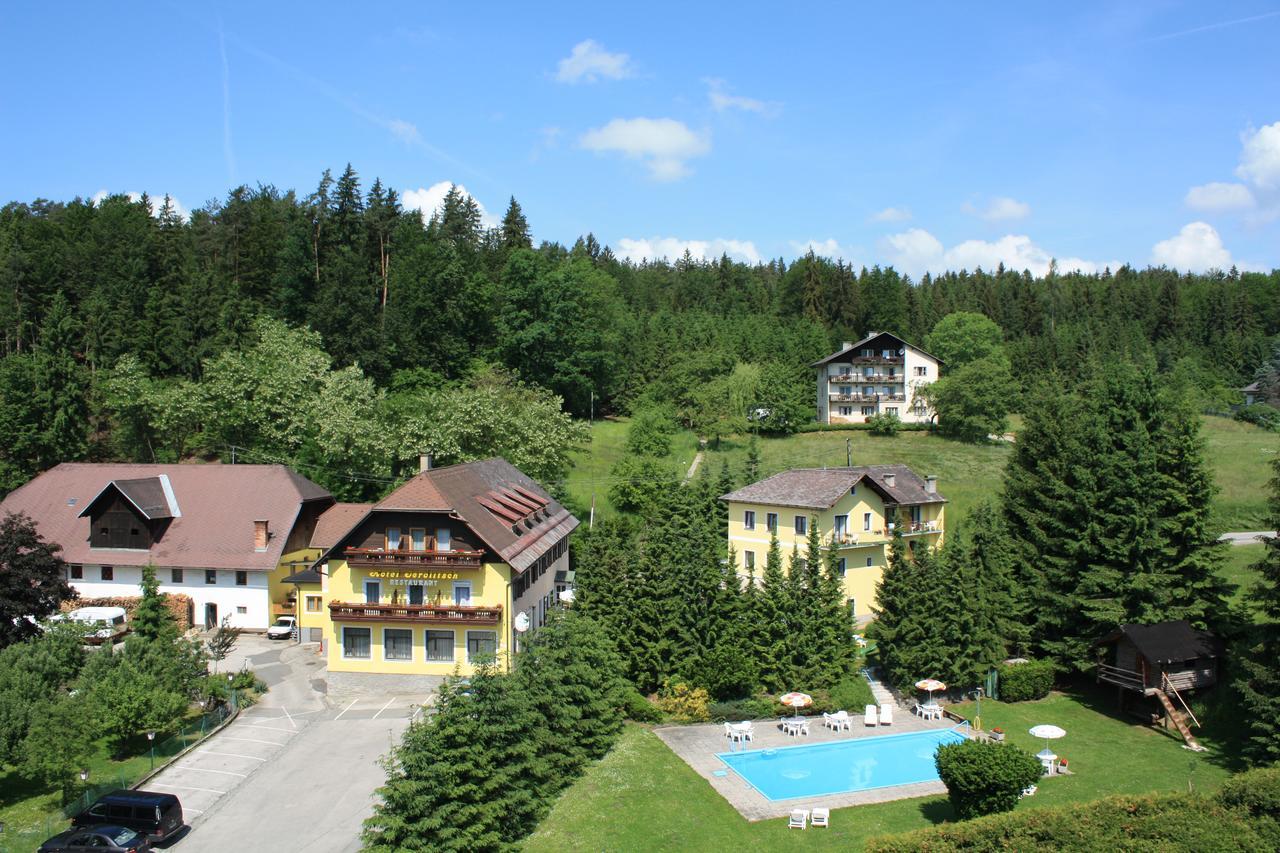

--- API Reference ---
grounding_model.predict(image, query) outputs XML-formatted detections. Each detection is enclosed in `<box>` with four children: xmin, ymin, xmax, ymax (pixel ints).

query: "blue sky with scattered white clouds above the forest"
<box><xmin>0</xmin><ymin>1</ymin><xmax>1280</xmax><ymax>275</ymax></box>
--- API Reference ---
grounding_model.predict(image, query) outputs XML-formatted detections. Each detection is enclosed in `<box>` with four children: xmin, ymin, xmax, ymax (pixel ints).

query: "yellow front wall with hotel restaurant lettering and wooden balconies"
<box><xmin>320</xmin><ymin>550</ymin><xmax>512</xmax><ymax>676</ymax></box>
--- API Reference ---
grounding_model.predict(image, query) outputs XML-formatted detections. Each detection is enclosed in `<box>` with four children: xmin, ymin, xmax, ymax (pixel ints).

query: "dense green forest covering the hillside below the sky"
<box><xmin>0</xmin><ymin>165</ymin><xmax>1280</xmax><ymax>498</ymax></box>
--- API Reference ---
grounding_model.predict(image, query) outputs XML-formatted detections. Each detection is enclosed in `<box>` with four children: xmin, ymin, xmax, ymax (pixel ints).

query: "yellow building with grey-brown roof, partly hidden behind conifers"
<box><xmin>721</xmin><ymin>465</ymin><xmax>947</xmax><ymax>621</ymax></box>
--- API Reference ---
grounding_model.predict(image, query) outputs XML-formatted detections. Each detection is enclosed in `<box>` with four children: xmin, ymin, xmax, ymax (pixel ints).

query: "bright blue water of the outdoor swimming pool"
<box><xmin>717</xmin><ymin>729</ymin><xmax>965</xmax><ymax>799</ymax></box>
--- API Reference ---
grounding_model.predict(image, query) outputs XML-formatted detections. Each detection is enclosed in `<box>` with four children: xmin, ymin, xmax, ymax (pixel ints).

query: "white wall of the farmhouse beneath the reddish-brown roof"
<box><xmin>68</xmin><ymin>565</ymin><xmax>271</xmax><ymax>630</ymax></box>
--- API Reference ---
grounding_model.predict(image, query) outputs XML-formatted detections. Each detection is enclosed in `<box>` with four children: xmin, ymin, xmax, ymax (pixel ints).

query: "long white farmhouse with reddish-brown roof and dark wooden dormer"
<box><xmin>0</xmin><ymin>462</ymin><xmax>333</xmax><ymax>630</ymax></box>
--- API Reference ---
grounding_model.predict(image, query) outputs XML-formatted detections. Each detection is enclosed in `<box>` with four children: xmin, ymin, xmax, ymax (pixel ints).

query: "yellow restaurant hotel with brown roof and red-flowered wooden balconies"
<box><xmin>288</xmin><ymin>459</ymin><xmax>579</xmax><ymax>689</ymax></box>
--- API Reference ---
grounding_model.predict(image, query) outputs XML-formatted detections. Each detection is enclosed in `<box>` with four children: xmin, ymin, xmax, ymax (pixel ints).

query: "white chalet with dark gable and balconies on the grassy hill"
<box><xmin>810</xmin><ymin>332</ymin><xmax>941</xmax><ymax>424</ymax></box>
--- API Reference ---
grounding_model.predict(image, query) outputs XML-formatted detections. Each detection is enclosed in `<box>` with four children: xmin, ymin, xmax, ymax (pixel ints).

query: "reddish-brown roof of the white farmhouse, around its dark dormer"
<box><xmin>0</xmin><ymin>462</ymin><xmax>333</xmax><ymax>571</ymax></box>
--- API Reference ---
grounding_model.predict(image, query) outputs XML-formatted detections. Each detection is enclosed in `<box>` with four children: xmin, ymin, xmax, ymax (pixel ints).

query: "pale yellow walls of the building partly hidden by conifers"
<box><xmin>728</xmin><ymin>483</ymin><xmax>946</xmax><ymax>619</ymax></box>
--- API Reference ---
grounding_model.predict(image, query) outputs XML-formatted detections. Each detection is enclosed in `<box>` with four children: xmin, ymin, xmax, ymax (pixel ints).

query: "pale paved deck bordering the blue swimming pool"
<box><xmin>653</xmin><ymin>708</ymin><xmax>956</xmax><ymax>821</ymax></box>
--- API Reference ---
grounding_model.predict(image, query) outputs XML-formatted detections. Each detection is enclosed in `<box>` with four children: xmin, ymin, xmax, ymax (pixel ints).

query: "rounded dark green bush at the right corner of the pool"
<box><xmin>933</xmin><ymin>740</ymin><xmax>1042</xmax><ymax>820</ymax></box>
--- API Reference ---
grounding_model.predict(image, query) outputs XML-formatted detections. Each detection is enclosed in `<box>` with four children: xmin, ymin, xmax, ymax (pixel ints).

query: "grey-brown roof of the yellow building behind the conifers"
<box><xmin>721</xmin><ymin>465</ymin><xmax>946</xmax><ymax>510</ymax></box>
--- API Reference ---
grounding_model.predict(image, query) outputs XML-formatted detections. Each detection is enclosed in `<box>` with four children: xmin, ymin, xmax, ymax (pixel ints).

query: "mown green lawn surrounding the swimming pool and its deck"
<box><xmin>525</xmin><ymin>688</ymin><xmax>1228</xmax><ymax>852</ymax></box>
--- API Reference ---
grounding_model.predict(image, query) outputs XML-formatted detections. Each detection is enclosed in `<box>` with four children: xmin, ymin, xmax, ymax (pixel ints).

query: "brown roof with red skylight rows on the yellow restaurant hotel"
<box><xmin>325</xmin><ymin>457</ymin><xmax>579</xmax><ymax>571</ymax></box>
